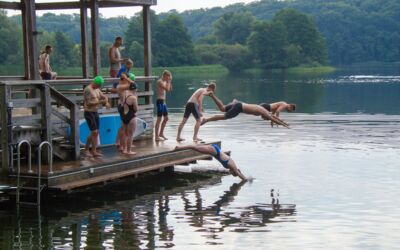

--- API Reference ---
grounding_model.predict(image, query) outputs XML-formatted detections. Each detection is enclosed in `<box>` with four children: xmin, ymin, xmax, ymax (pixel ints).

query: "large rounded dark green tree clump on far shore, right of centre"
<box><xmin>248</xmin><ymin>9</ymin><xmax>327</xmax><ymax>68</ymax></box>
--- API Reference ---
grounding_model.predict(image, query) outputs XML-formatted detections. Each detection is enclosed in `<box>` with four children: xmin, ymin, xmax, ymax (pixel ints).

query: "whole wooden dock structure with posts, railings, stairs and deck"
<box><xmin>0</xmin><ymin>0</ymin><xmax>225</xmax><ymax>200</ymax></box>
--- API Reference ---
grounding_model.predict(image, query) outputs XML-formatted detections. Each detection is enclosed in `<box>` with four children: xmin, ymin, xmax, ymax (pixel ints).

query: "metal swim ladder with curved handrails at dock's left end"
<box><xmin>16</xmin><ymin>140</ymin><xmax>53</xmax><ymax>206</ymax></box>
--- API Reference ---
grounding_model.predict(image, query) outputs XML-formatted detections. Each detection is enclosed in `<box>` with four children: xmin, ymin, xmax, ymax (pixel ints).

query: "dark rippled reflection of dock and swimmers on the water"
<box><xmin>0</xmin><ymin>174</ymin><xmax>295</xmax><ymax>249</ymax></box>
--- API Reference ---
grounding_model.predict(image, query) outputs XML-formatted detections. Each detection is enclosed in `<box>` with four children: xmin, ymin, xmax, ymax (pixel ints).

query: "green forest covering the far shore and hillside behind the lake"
<box><xmin>0</xmin><ymin>0</ymin><xmax>400</xmax><ymax>71</ymax></box>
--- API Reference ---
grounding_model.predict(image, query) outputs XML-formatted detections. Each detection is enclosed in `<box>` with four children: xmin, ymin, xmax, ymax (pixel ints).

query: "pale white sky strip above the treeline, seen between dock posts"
<box><xmin>6</xmin><ymin>0</ymin><xmax>257</xmax><ymax>18</ymax></box>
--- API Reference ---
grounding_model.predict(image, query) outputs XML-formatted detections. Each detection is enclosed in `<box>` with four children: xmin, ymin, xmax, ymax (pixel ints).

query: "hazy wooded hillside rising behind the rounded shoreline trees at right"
<box><xmin>181</xmin><ymin>0</ymin><xmax>400</xmax><ymax>65</ymax></box>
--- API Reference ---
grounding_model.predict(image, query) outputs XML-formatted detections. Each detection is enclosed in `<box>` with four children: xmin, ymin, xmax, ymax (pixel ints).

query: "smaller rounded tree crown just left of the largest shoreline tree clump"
<box><xmin>214</xmin><ymin>12</ymin><xmax>255</xmax><ymax>44</ymax></box>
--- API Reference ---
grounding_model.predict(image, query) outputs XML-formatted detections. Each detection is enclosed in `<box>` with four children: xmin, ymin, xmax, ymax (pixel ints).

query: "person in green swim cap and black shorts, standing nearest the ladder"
<box><xmin>83</xmin><ymin>76</ymin><xmax>111</xmax><ymax>157</ymax></box>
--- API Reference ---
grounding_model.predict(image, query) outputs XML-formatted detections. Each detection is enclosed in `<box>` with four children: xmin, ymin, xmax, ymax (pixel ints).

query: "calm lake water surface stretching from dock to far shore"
<box><xmin>0</xmin><ymin>63</ymin><xmax>400</xmax><ymax>249</ymax></box>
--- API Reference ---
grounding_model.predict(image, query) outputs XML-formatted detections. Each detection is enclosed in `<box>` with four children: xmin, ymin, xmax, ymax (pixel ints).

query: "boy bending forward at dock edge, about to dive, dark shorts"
<box><xmin>176</xmin><ymin>82</ymin><xmax>216</xmax><ymax>142</ymax></box>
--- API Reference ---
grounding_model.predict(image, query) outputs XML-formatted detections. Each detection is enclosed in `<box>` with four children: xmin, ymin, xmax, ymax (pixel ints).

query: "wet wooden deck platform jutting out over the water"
<box><xmin>10</xmin><ymin>140</ymin><xmax>221</xmax><ymax>190</ymax></box>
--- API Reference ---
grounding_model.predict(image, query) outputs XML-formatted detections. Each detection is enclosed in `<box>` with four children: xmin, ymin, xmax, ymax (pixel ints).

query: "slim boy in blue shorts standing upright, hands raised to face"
<box><xmin>155</xmin><ymin>70</ymin><xmax>172</xmax><ymax>141</ymax></box>
